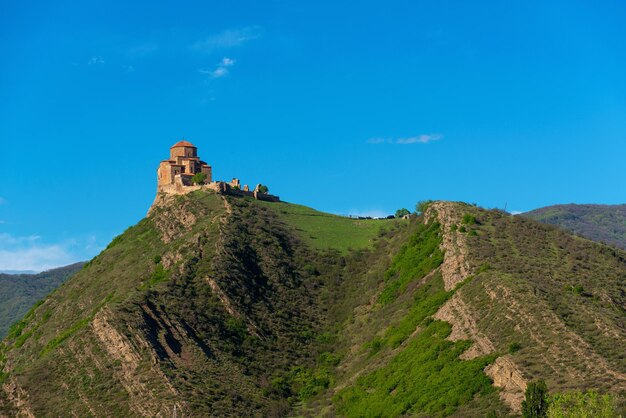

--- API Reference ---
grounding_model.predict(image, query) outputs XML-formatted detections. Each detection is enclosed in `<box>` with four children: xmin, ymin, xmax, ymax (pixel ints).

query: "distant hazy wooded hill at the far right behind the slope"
<box><xmin>521</xmin><ymin>204</ymin><xmax>626</xmax><ymax>248</ymax></box>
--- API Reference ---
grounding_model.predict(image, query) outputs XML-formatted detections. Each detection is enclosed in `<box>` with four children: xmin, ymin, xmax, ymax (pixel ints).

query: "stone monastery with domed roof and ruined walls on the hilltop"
<box><xmin>157</xmin><ymin>141</ymin><xmax>280</xmax><ymax>202</ymax></box>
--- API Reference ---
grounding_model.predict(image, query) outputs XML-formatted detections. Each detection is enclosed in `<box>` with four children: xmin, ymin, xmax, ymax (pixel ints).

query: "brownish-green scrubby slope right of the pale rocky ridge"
<box><xmin>454</xmin><ymin>206</ymin><xmax>626</xmax><ymax>394</ymax></box>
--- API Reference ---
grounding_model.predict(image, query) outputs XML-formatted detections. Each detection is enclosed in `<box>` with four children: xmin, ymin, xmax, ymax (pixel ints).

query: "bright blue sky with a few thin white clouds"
<box><xmin>0</xmin><ymin>0</ymin><xmax>626</xmax><ymax>270</ymax></box>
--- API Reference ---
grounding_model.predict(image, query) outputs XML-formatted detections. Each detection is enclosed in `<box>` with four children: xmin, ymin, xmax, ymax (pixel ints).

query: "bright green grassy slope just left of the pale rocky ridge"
<box><xmin>304</xmin><ymin>216</ymin><xmax>506</xmax><ymax>417</ymax></box>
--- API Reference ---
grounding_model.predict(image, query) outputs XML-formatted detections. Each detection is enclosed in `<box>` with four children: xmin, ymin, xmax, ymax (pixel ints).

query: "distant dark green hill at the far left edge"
<box><xmin>0</xmin><ymin>263</ymin><xmax>84</xmax><ymax>338</ymax></box>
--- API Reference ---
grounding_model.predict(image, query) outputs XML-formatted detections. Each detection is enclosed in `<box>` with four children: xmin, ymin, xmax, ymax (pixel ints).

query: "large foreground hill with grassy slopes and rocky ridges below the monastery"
<box><xmin>0</xmin><ymin>192</ymin><xmax>626</xmax><ymax>417</ymax></box>
